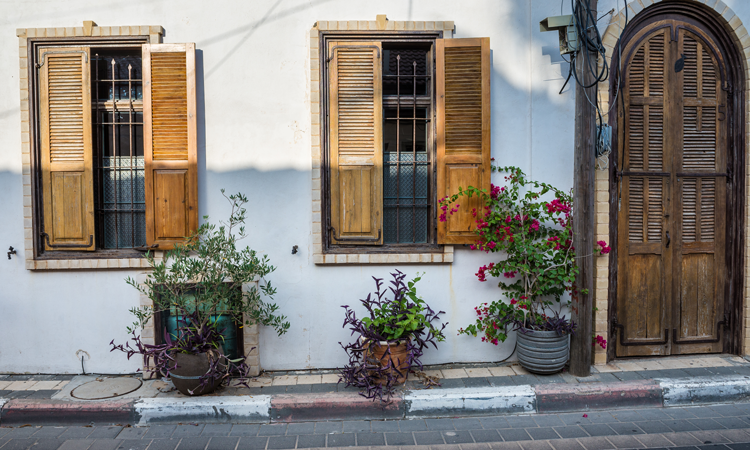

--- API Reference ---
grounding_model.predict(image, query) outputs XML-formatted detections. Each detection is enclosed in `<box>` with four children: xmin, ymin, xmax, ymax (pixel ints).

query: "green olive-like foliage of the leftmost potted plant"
<box><xmin>126</xmin><ymin>189</ymin><xmax>289</xmax><ymax>347</ymax></box>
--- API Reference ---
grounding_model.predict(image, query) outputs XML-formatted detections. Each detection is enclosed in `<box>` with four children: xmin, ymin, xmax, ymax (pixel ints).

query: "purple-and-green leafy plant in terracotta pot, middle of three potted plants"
<box><xmin>339</xmin><ymin>270</ymin><xmax>448</xmax><ymax>402</ymax></box>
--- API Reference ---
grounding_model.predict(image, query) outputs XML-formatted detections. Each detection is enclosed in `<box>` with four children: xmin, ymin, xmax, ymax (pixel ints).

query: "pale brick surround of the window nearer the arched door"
<box><xmin>310</xmin><ymin>15</ymin><xmax>462</xmax><ymax>265</ymax></box>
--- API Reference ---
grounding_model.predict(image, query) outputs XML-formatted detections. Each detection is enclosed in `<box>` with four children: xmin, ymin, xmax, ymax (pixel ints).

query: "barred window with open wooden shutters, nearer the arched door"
<box><xmin>320</xmin><ymin>31</ymin><xmax>491</xmax><ymax>253</ymax></box>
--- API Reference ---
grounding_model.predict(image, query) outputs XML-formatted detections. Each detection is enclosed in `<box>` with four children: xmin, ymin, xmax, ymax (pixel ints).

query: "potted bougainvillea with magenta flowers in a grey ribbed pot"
<box><xmin>440</xmin><ymin>166</ymin><xmax>578</xmax><ymax>373</ymax></box>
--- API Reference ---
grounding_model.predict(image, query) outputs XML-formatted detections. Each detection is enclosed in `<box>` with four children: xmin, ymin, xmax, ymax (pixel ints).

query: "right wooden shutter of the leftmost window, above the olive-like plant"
<box><xmin>143</xmin><ymin>44</ymin><xmax>198</xmax><ymax>250</ymax></box>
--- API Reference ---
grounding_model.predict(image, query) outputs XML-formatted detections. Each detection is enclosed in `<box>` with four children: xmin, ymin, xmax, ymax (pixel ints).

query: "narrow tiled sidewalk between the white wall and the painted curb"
<box><xmin>0</xmin><ymin>355</ymin><xmax>750</xmax><ymax>399</ymax></box>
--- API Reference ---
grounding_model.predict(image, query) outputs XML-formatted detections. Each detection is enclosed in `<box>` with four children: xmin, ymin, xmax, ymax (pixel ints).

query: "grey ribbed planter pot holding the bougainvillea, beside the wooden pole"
<box><xmin>516</xmin><ymin>331</ymin><xmax>570</xmax><ymax>374</ymax></box>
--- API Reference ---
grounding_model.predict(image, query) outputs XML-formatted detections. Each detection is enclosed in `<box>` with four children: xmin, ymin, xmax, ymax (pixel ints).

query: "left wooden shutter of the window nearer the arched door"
<box><xmin>328</xmin><ymin>42</ymin><xmax>383</xmax><ymax>245</ymax></box>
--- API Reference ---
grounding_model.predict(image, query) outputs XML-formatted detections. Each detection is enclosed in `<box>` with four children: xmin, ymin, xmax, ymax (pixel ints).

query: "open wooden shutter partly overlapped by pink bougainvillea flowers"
<box><xmin>436</xmin><ymin>38</ymin><xmax>492</xmax><ymax>244</ymax></box>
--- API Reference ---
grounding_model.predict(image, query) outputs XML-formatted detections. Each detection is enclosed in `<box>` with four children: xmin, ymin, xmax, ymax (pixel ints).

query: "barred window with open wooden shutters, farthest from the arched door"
<box><xmin>29</xmin><ymin>40</ymin><xmax>198</xmax><ymax>259</ymax></box>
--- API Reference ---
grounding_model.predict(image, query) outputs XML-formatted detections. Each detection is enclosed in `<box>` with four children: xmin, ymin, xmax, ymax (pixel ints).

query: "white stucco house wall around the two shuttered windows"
<box><xmin>0</xmin><ymin>0</ymin><xmax>750</xmax><ymax>373</ymax></box>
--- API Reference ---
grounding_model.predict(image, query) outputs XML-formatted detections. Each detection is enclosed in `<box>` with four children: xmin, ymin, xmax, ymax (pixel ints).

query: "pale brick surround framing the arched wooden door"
<box><xmin>593</xmin><ymin>0</ymin><xmax>750</xmax><ymax>364</ymax></box>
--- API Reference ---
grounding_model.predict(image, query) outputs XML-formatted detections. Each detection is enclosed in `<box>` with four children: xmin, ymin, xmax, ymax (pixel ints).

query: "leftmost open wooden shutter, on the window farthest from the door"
<box><xmin>39</xmin><ymin>47</ymin><xmax>95</xmax><ymax>251</ymax></box>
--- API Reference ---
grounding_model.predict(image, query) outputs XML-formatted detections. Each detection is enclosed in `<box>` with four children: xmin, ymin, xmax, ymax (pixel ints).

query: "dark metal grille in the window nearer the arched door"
<box><xmin>383</xmin><ymin>48</ymin><xmax>432</xmax><ymax>244</ymax></box>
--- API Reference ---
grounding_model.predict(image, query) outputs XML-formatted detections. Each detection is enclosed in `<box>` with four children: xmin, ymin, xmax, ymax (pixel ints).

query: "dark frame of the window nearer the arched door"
<box><xmin>318</xmin><ymin>30</ymin><xmax>443</xmax><ymax>254</ymax></box>
